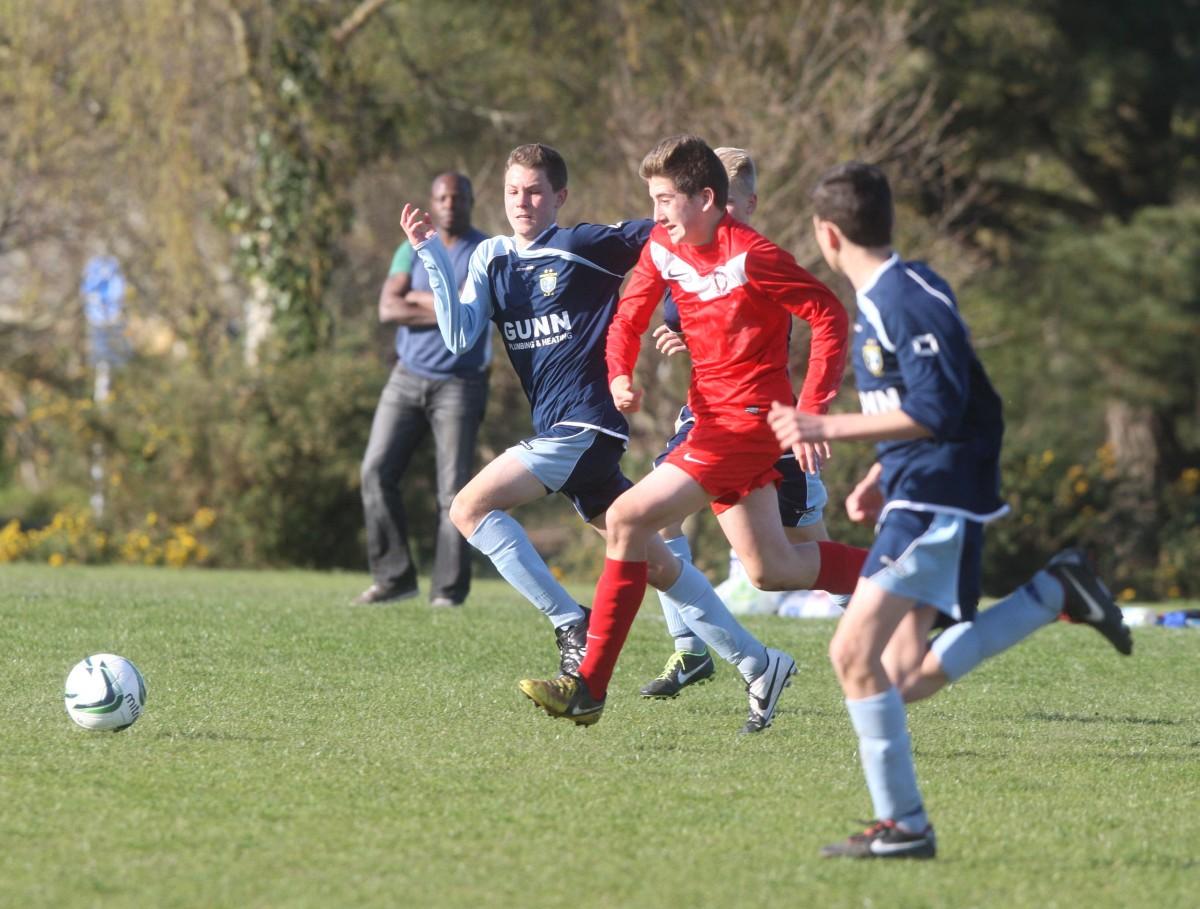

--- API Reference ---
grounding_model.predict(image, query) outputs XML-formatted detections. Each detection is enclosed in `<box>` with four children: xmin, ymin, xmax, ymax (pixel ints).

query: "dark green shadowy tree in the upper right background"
<box><xmin>918</xmin><ymin>0</ymin><xmax>1200</xmax><ymax>582</ymax></box>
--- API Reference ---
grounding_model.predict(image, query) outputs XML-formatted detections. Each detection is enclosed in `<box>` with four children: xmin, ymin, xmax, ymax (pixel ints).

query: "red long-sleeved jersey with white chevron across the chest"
<box><xmin>606</xmin><ymin>215</ymin><xmax>848</xmax><ymax>422</ymax></box>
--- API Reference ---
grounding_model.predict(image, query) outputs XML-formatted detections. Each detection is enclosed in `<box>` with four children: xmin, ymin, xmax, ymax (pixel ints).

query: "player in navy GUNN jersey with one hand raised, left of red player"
<box><xmin>401</xmin><ymin>145</ymin><xmax>792</xmax><ymax>724</ymax></box>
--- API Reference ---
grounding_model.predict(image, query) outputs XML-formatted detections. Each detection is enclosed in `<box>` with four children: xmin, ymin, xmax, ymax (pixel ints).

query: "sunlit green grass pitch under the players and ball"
<box><xmin>0</xmin><ymin>566</ymin><xmax>1200</xmax><ymax>909</ymax></box>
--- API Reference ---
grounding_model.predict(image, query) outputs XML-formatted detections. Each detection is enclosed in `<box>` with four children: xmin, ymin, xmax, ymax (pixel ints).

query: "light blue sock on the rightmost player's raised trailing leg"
<box><xmin>932</xmin><ymin>571</ymin><xmax>1062</xmax><ymax>681</ymax></box>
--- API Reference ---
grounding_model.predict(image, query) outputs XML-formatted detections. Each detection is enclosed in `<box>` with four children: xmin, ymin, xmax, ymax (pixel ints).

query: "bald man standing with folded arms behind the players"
<box><xmin>354</xmin><ymin>173</ymin><xmax>492</xmax><ymax>607</ymax></box>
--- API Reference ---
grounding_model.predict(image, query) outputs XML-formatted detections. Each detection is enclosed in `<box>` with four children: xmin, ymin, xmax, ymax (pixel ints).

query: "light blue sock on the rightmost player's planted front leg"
<box><xmin>846</xmin><ymin>685</ymin><xmax>929</xmax><ymax>832</ymax></box>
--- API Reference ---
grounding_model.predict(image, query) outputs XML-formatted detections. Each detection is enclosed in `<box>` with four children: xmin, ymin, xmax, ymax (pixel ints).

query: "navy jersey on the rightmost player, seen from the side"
<box><xmin>853</xmin><ymin>255</ymin><xmax>1007</xmax><ymax>522</ymax></box>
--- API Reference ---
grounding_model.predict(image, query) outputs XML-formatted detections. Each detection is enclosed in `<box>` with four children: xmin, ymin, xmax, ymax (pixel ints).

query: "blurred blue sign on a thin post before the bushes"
<box><xmin>79</xmin><ymin>255</ymin><xmax>130</xmax><ymax>518</ymax></box>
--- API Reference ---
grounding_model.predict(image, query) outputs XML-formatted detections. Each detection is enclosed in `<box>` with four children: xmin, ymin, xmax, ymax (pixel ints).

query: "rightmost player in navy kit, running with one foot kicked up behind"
<box><xmin>770</xmin><ymin>163</ymin><xmax>1133</xmax><ymax>859</ymax></box>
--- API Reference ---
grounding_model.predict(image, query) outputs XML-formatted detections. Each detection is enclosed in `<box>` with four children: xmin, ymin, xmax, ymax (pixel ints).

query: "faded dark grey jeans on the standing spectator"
<box><xmin>362</xmin><ymin>363</ymin><xmax>487</xmax><ymax>602</ymax></box>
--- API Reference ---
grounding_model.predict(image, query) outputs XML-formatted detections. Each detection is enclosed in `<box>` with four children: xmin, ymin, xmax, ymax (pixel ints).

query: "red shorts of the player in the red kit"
<box><xmin>665</xmin><ymin>419</ymin><xmax>782</xmax><ymax>514</ymax></box>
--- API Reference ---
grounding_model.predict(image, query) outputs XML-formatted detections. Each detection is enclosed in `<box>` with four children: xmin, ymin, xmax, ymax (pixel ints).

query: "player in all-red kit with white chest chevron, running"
<box><xmin>521</xmin><ymin>136</ymin><xmax>866</xmax><ymax>730</ymax></box>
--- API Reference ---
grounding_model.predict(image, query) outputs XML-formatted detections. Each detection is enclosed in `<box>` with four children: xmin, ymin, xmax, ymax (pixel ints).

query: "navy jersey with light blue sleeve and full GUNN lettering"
<box><xmin>418</xmin><ymin>221</ymin><xmax>654</xmax><ymax>439</ymax></box>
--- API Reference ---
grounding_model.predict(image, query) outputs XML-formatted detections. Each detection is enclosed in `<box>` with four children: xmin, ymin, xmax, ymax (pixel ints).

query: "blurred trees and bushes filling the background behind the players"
<box><xmin>0</xmin><ymin>0</ymin><xmax>1200</xmax><ymax>600</ymax></box>
